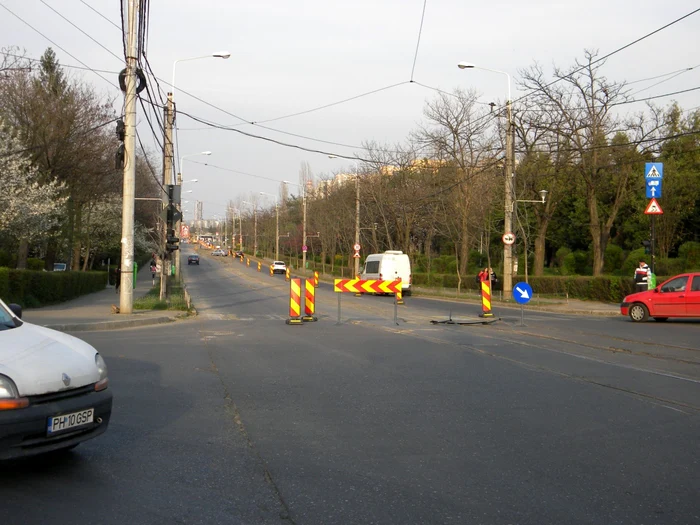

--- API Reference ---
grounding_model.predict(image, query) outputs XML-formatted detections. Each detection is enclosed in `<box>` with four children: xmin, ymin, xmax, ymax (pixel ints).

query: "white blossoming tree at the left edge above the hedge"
<box><xmin>0</xmin><ymin>121</ymin><xmax>65</xmax><ymax>268</ymax></box>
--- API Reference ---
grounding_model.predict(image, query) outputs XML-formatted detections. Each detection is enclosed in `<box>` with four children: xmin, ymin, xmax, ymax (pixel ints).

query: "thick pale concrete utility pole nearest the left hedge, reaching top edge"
<box><xmin>118</xmin><ymin>0</ymin><xmax>139</xmax><ymax>314</ymax></box>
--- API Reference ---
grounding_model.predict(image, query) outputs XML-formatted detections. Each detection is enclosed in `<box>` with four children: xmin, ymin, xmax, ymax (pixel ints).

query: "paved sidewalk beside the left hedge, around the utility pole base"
<box><xmin>22</xmin><ymin>268</ymin><xmax>183</xmax><ymax>332</ymax></box>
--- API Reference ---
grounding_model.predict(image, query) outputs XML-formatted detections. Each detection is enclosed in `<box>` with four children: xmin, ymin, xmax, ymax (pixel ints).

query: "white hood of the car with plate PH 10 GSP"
<box><xmin>0</xmin><ymin>322</ymin><xmax>100</xmax><ymax>396</ymax></box>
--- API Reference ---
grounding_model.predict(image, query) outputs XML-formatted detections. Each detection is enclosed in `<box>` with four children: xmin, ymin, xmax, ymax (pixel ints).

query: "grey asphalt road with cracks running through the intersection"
<box><xmin>0</xmin><ymin>254</ymin><xmax>700</xmax><ymax>525</ymax></box>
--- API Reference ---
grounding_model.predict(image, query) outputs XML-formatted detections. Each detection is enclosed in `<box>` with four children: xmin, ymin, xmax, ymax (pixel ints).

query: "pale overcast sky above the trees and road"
<box><xmin>0</xmin><ymin>0</ymin><xmax>700</xmax><ymax>219</ymax></box>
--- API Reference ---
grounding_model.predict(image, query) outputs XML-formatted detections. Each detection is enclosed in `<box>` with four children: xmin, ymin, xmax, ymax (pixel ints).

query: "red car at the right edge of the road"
<box><xmin>620</xmin><ymin>272</ymin><xmax>700</xmax><ymax>322</ymax></box>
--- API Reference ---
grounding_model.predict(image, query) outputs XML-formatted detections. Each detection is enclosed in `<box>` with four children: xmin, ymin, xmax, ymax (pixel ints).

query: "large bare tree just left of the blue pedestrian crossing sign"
<box><xmin>521</xmin><ymin>51</ymin><xmax>658</xmax><ymax>275</ymax></box>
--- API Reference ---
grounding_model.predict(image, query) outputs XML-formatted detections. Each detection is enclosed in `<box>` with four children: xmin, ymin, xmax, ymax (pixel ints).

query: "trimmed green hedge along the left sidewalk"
<box><xmin>0</xmin><ymin>268</ymin><xmax>107</xmax><ymax>308</ymax></box>
